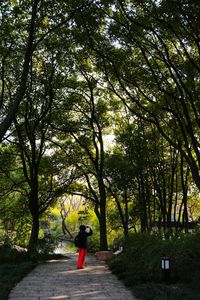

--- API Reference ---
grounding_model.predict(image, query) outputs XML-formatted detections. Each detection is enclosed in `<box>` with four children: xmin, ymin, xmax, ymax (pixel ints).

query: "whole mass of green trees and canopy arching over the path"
<box><xmin>0</xmin><ymin>0</ymin><xmax>200</xmax><ymax>255</ymax></box>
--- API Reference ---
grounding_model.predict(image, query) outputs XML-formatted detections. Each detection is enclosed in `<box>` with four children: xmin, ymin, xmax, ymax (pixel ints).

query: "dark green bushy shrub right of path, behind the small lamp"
<box><xmin>109</xmin><ymin>233</ymin><xmax>200</xmax><ymax>286</ymax></box>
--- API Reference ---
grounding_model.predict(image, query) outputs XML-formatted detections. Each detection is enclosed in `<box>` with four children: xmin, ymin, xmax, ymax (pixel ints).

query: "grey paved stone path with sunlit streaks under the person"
<box><xmin>8</xmin><ymin>254</ymin><xmax>136</xmax><ymax>300</ymax></box>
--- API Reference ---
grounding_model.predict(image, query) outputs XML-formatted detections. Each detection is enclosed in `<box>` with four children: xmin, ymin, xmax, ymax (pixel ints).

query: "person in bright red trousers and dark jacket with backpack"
<box><xmin>77</xmin><ymin>225</ymin><xmax>93</xmax><ymax>269</ymax></box>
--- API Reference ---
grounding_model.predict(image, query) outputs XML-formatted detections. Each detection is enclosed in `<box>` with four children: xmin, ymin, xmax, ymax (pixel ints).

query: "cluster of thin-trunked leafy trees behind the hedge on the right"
<box><xmin>105</xmin><ymin>109</ymin><xmax>198</xmax><ymax>234</ymax></box>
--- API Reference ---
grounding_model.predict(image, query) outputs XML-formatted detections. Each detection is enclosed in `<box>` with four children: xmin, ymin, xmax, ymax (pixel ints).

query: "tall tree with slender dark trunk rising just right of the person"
<box><xmin>50</xmin><ymin>50</ymin><xmax>109</xmax><ymax>250</ymax></box>
